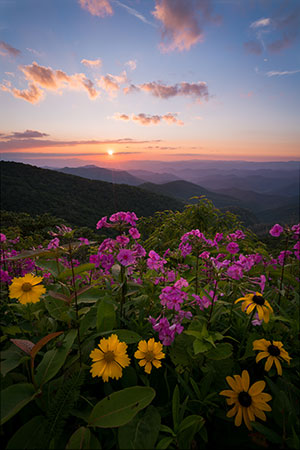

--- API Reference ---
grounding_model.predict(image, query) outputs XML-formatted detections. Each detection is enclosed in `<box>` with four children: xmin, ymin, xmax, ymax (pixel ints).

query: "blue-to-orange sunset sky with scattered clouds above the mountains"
<box><xmin>0</xmin><ymin>0</ymin><xmax>300</xmax><ymax>168</ymax></box>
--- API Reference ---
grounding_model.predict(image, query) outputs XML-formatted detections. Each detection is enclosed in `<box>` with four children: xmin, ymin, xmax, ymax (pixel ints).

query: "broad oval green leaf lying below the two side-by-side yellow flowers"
<box><xmin>89</xmin><ymin>386</ymin><xmax>155</xmax><ymax>428</ymax></box>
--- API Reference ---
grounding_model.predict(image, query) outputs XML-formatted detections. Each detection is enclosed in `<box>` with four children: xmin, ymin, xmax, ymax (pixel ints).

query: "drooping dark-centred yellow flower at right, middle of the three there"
<box><xmin>253</xmin><ymin>339</ymin><xmax>292</xmax><ymax>375</ymax></box>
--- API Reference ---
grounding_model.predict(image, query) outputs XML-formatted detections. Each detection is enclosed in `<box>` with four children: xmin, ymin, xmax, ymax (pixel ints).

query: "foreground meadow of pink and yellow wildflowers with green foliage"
<box><xmin>0</xmin><ymin>198</ymin><xmax>300</xmax><ymax>450</ymax></box>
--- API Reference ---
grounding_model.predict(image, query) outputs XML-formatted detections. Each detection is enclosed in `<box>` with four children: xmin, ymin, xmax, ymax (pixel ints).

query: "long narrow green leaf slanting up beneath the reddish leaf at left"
<box><xmin>36</xmin><ymin>330</ymin><xmax>77</xmax><ymax>386</ymax></box>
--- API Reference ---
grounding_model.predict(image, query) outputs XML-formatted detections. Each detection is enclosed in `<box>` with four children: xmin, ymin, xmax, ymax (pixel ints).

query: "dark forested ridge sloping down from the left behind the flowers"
<box><xmin>0</xmin><ymin>161</ymin><xmax>183</xmax><ymax>229</ymax></box>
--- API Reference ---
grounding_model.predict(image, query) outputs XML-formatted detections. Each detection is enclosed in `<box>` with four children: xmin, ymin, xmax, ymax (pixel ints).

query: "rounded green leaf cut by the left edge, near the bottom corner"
<box><xmin>0</xmin><ymin>383</ymin><xmax>37</xmax><ymax>425</ymax></box>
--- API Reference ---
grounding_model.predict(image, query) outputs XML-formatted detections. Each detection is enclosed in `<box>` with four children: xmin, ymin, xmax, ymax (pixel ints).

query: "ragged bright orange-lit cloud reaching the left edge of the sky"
<box><xmin>0</xmin><ymin>61</ymin><xmax>99</xmax><ymax>103</ymax></box>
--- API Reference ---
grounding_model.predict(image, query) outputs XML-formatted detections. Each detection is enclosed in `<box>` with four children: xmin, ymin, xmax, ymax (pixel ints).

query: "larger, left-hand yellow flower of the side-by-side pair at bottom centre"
<box><xmin>90</xmin><ymin>334</ymin><xmax>130</xmax><ymax>381</ymax></box>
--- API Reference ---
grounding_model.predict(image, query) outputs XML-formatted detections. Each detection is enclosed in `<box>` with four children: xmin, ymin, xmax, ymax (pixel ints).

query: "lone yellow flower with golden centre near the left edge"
<box><xmin>9</xmin><ymin>273</ymin><xmax>46</xmax><ymax>305</ymax></box>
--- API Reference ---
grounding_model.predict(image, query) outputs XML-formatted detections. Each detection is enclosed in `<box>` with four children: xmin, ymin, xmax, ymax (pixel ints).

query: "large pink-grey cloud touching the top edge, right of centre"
<box><xmin>152</xmin><ymin>0</ymin><xmax>219</xmax><ymax>51</ymax></box>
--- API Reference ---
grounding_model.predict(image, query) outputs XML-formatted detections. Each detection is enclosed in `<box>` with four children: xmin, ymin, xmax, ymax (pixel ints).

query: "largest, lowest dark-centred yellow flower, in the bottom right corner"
<box><xmin>220</xmin><ymin>370</ymin><xmax>272</xmax><ymax>430</ymax></box>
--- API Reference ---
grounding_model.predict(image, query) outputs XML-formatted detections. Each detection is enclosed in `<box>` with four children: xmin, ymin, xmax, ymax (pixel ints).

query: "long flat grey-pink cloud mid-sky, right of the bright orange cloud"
<box><xmin>135</xmin><ymin>81</ymin><xmax>209</xmax><ymax>101</ymax></box>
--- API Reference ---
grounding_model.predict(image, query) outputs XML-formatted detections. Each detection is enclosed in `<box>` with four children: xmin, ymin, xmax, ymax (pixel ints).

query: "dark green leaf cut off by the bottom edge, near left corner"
<box><xmin>6</xmin><ymin>416</ymin><xmax>46</xmax><ymax>450</ymax></box>
